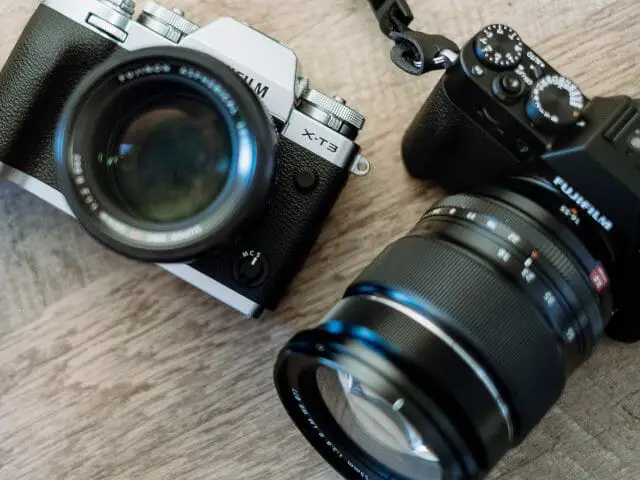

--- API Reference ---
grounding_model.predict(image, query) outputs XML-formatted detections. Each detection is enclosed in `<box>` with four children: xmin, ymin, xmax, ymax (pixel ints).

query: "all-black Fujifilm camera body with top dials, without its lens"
<box><xmin>403</xmin><ymin>24</ymin><xmax>640</xmax><ymax>341</ymax></box>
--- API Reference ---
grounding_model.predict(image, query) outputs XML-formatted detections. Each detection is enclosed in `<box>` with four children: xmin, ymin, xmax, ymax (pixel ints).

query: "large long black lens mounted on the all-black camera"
<box><xmin>274</xmin><ymin>177</ymin><xmax>613</xmax><ymax>480</ymax></box>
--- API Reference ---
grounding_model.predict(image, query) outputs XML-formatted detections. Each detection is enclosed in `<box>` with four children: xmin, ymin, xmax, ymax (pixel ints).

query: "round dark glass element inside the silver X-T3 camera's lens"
<box><xmin>104</xmin><ymin>96</ymin><xmax>232</xmax><ymax>223</ymax></box>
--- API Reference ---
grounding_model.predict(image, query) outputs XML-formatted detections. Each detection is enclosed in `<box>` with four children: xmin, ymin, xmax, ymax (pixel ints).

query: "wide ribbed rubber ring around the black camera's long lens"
<box><xmin>347</xmin><ymin>237</ymin><xmax>565</xmax><ymax>438</ymax></box>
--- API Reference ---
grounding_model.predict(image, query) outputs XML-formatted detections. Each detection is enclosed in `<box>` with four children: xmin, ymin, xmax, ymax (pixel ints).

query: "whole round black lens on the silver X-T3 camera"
<box><xmin>55</xmin><ymin>48</ymin><xmax>276</xmax><ymax>263</ymax></box>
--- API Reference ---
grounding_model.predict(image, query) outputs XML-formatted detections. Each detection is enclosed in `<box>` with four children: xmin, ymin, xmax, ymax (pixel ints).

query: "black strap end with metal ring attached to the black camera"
<box><xmin>368</xmin><ymin>0</ymin><xmax>460</xmax><ymax>75</ymax></box>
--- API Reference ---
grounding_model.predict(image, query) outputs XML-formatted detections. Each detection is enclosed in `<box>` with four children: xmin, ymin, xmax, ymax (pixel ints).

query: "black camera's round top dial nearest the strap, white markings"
<box><xmin>475</xmin><ymin>24</ymin><xmax>524</xmax><ymax>70</ymax></box>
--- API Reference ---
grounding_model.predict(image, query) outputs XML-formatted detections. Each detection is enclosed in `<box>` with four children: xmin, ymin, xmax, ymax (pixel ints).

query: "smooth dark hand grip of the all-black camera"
<box><xmin>402</xmin><ymin>73</ymin><xmax>517</xmax><ymax>191</ymax></box>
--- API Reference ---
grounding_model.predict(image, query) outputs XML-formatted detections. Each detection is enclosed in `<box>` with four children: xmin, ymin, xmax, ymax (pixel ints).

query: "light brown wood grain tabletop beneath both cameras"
<box><xmin>0</xmin><ymin>0</ymin><xmax>640</xmax><ymax>480</ymax></box>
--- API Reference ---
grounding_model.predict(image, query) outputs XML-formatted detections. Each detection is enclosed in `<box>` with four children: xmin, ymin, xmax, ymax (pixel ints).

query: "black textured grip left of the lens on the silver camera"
<box><xmin>0</xmin><ymin>5</ymin><xmax>119</xmax><ymax>188</ymax></box>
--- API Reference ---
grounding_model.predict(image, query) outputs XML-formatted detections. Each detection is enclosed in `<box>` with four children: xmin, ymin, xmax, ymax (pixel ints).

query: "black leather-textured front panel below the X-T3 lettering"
<box><xmin>192</xmin><ymin>136</ymin><xmax>350</xmax><ymax>310</ymax></box>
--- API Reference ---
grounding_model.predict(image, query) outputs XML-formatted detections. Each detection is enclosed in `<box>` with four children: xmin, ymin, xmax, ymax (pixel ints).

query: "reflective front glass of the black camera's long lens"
<box><xmin>316</xmin><ymin>367</ymin><xmax>442</xmax><ymax>480</ymax></box>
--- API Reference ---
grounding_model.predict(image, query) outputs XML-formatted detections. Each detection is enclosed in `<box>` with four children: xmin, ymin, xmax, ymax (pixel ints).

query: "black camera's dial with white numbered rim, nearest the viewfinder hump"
<box><xmin>527</xmin><ymin>75</ymin><xmax>585</xmax><ymax>131</ymax></box>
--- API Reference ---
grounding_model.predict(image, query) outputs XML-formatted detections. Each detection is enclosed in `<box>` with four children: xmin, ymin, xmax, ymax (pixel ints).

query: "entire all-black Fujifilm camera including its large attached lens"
<box><xmin>274</xmin><ymin>23</ymin><xmax>640</xmax><ymax>480</ymax></box>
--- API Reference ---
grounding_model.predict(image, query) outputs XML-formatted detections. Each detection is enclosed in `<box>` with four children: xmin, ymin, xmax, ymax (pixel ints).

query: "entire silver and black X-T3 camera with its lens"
<box><xmin>0</xmin><ymin>0</ymin><xmax>368</xmax><ymax>316</ymax></box>
